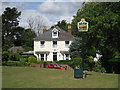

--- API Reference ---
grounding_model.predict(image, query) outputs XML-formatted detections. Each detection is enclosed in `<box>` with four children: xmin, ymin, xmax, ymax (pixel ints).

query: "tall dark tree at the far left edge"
<box><xmin>2</xmin><ymin>7</ymin><xmax>21</xmax><ymax>50</ymax></box>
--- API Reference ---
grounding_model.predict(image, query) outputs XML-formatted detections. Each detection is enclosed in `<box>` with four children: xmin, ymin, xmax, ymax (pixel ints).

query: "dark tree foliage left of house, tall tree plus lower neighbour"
<box><xmin>1</xmin><ymin>7</ymin><xmax>36</xmax><ymax>51</ymax></box>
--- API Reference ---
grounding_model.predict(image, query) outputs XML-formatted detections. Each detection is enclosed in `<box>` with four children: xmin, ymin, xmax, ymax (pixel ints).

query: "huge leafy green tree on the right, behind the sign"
<box><xmin>72</xmin><ymin>2</ymin><xmax>120</xmax><ymax>73</ymax></box>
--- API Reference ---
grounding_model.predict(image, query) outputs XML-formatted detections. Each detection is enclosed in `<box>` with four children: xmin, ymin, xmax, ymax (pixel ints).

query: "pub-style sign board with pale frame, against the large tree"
<box><xmin>77</xmin><ymin>19</ymin><xmax>88</xmax><ymax>32</ymax></box>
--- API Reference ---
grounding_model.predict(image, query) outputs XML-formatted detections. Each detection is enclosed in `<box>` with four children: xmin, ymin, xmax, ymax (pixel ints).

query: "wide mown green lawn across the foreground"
<box><xmin>2</xmin><ymin>67</ymin><xmax>118</xmax><ymax>88</ymax></box>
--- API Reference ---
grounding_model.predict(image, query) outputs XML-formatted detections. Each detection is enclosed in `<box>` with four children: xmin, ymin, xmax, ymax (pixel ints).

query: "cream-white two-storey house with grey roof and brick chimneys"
<box><xmin>34</xmin><ymin>26</ymin><xmax>74</xmax><ymax>61</ymax></box>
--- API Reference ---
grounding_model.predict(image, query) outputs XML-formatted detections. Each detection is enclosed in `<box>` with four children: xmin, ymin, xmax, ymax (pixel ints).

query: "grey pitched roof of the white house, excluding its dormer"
<box><xmin>34</xmin><ymin>26</ymin><xmax>75</xmax><ymax>41</ymax></box>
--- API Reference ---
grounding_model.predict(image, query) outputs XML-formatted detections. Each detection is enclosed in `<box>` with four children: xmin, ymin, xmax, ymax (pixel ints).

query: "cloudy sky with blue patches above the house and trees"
<box><xmin>0</xmin><ymin>1</ymin><xmax>82</xmax><ymax>27</ymax></box>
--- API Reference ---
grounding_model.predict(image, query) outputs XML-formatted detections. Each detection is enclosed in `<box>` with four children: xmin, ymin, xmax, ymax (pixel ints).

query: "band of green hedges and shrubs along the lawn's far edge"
<box><xmin>2</xmin><ymin>51</ymin><xmax>106</xmax><ymax>73</ymax></box>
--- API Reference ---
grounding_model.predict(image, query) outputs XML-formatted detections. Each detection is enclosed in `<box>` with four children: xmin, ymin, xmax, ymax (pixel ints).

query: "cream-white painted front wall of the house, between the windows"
<box><xmin>34</xmin><ymin>41</ymin><xmax>72</xmax><ymax>61</ymax></box>
